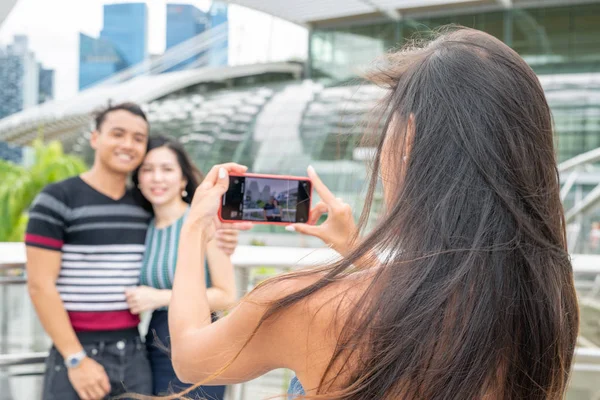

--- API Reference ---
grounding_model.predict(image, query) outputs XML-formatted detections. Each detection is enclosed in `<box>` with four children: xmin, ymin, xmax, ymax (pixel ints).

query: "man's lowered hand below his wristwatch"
<box><xmin>67</xmin><ymin>357</ymin><xmax>110</xmax><ymax>400</ymax></box>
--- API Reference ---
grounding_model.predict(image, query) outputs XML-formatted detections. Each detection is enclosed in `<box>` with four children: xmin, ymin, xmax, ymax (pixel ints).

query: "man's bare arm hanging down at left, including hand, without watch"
<box><xmin>27</xmin><ymin>246</ymin><xmax>110</xmax><ymax>400</ymax></box>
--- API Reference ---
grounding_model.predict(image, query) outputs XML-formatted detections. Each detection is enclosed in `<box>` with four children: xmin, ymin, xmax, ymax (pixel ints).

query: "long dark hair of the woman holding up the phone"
<box><xmin>246</xmin><ymin>29</ymin><xmax>579</xmax><ymax>400</ymax></box>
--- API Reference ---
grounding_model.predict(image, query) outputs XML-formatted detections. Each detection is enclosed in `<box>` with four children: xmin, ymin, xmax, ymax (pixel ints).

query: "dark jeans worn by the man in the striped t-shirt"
<box><xmin>42</xmin><ymin>338</ymin><xmax>152</xmax><ymax>400</ymax></box>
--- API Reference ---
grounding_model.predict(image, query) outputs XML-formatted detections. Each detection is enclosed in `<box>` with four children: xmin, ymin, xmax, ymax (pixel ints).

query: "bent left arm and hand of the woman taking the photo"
<box><xmin>169</xmin><ymin>164</ymin><xmax>298</xmax><ymax>384</ymax></box>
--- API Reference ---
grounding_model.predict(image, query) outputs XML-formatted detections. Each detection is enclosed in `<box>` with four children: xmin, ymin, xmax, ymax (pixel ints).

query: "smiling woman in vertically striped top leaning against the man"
<box><xmin>126</xmin><ymin>136</ymin><xmax>248</xmax><ymax>400</ymax></box>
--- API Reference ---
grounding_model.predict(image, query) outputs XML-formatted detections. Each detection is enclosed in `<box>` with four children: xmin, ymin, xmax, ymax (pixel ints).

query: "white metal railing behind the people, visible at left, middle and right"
<box><xmin>0</xmin><ymin>243</ymin><xmax>600</xmax><ymax>400</ymax></box>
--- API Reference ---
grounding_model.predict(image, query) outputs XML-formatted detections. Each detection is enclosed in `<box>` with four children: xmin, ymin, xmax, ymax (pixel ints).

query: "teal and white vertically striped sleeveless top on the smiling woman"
<box><xmin>140</xmin><ymin>208</ymin><xmax>211</xmax><ymax>304</ymax></box>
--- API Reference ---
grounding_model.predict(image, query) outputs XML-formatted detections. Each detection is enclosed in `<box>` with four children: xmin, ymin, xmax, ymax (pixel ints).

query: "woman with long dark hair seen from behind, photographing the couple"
<box><xmin>163</xmin><ymin>29</ymin><xmax>578</xmax><ymax>400</ymax></box>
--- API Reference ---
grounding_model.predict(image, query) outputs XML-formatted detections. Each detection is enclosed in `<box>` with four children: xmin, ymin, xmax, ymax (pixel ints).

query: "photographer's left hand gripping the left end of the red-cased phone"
<box><xmin>184</xmin><ymin>163</ymin><xmax>248</xmax><ymax>238</ymax></box>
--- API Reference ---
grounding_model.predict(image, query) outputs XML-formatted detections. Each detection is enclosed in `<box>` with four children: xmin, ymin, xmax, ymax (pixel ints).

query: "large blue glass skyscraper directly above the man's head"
<box><xmin>79</xmin><ymin>3</ymin><xmax>148</xmax><ymax>90</ymax></box>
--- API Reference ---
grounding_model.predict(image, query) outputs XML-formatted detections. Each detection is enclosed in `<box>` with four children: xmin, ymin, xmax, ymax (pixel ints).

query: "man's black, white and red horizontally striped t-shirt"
<box><xmin>25</xmin><ymin>177</ymin><xmax>150</xmax><ymax>331</ymax></box>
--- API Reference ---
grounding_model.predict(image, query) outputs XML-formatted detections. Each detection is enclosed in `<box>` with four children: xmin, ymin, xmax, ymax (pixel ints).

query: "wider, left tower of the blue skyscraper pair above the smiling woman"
<box><xmin>167</xmin><ymin>4</ymin><xmax>209</xmax><ymax>72</ymax></box>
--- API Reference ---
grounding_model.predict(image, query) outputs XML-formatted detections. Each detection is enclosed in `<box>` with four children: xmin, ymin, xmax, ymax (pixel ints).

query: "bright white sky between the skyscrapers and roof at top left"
<box><xmin>0</xmin><ymin>0</ymin><xmax>308</xmax><ymax>99</ymax></box>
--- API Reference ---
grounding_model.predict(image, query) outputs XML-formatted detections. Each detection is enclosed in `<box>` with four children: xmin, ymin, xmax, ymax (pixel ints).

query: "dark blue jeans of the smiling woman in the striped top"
<box><xmin>146</xmin><ymin>310</ymin><xmax>225</xmax><ymax>400</ymax></box>
